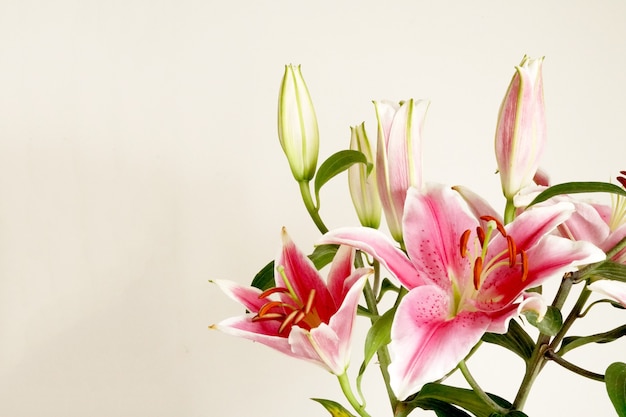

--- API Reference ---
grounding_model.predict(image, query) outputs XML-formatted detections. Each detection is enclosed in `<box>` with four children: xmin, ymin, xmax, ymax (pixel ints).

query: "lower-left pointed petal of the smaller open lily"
<box><xmin>210</xmin><ymin>315</ymin><xmax>295</xmax><ymax>356</ymax></box>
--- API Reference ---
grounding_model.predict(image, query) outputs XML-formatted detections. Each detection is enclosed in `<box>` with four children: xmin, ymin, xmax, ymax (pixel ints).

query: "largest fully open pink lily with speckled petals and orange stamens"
<box><xmin>322</xmin><ymin>186</ymin><xmax>604</xmax><ymax>399</ymax></box>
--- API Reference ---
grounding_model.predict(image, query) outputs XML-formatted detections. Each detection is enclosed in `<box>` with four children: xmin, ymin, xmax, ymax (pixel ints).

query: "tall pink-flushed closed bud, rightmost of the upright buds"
<box><xmin>495</xmin><ymin>56</ymin><xmax>547</xmax><ymax>201</ymax></box>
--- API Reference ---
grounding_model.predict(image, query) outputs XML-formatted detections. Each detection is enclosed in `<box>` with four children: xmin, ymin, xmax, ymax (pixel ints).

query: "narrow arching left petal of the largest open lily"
<box><xmin>318</xmin><ymin>227</ymin><xmax>430</xmax><ymax>288</ymax></box>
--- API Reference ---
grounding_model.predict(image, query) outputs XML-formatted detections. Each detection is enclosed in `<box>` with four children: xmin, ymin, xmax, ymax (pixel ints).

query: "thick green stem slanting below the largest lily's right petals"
<box><xmin>513</xmin><ymin>275</ymin><xmax>573</xmax><ymax>411</ymax></box>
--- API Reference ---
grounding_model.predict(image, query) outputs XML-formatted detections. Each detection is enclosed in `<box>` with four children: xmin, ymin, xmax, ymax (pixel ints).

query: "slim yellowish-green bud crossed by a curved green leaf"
<box><xmin>348</xmin><ymin>123</ymin><xmax>382</xmax><ymax>229</ymax></box>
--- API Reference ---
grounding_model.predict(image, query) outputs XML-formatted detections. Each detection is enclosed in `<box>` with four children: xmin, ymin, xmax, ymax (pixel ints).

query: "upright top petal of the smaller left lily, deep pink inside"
<box><xmin>275</xmin><ymin>228</ymin><xmax>339</xmax><ymax>321</ymax></box>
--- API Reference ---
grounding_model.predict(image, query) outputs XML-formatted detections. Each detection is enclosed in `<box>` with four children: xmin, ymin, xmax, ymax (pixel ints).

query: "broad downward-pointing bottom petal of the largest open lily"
<box><xmin>389</xmin><ymin>285</ymin><xmax>490</xmax><ymax>400</ymax></box>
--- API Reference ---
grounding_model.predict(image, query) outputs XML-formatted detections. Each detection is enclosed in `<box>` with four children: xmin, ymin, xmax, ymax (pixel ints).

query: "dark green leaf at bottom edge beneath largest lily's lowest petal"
<box><xmin>409</xmin><ymin>383</ymin><xmax>525</xmax><ymax>417</ymax></box>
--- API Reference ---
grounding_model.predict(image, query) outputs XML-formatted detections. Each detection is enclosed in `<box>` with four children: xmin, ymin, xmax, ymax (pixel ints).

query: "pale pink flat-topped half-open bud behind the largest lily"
<box><xmin>374</xmin><ymin>99</ymin><xmax>429</xmax><ymax>242</ymax></box>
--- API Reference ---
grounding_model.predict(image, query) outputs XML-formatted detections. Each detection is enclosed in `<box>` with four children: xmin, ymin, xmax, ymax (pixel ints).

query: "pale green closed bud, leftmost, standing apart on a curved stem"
<box><xmin>278</xmin><ymin>65</ymin><xmax>319</xmax><ymax>182</ymax></box>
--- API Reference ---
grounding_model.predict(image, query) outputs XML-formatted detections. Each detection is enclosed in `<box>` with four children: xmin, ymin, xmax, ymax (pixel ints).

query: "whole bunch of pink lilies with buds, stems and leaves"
<box><xmin>210</xmin><ymin>57</ymin><xmax>626</xmax><ymax>417</ymax></box>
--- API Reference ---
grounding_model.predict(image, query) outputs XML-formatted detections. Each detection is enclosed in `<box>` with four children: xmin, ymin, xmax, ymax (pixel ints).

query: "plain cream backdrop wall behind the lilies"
<box><xmin>0</xmin><ymin>0</ymin><xmax>626</xmax><ymax>417</ymax></box>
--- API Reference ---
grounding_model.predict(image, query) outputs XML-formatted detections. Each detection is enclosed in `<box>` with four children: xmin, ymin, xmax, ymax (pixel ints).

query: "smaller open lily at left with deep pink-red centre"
<box><xmin>210</xmin><ymin>229</ymin><xmax>371</xmax><ymax>375</ymax></box>
